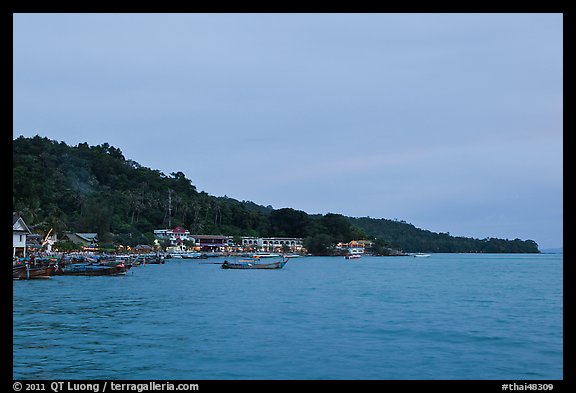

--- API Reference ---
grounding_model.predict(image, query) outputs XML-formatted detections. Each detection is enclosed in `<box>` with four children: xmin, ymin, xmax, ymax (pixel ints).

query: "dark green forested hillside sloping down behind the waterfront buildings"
<box><xmin>12</xmin><ymin>136</ymin><xmax>538</xmax><ymax>254</ymax></box>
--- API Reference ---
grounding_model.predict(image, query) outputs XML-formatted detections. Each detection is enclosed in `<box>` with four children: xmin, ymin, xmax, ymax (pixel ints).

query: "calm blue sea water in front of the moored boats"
<box><xmin>13</xmin><ymin>254</ymin><xmax>563</xmax><ymax>380</ymax></box>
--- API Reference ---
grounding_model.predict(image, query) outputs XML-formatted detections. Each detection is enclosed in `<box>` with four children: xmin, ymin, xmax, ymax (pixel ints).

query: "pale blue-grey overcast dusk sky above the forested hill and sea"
<box><xmin>13</xmin><ymin>13</ymin><xmax>563</xmax><ymax>249</ymax></box>
